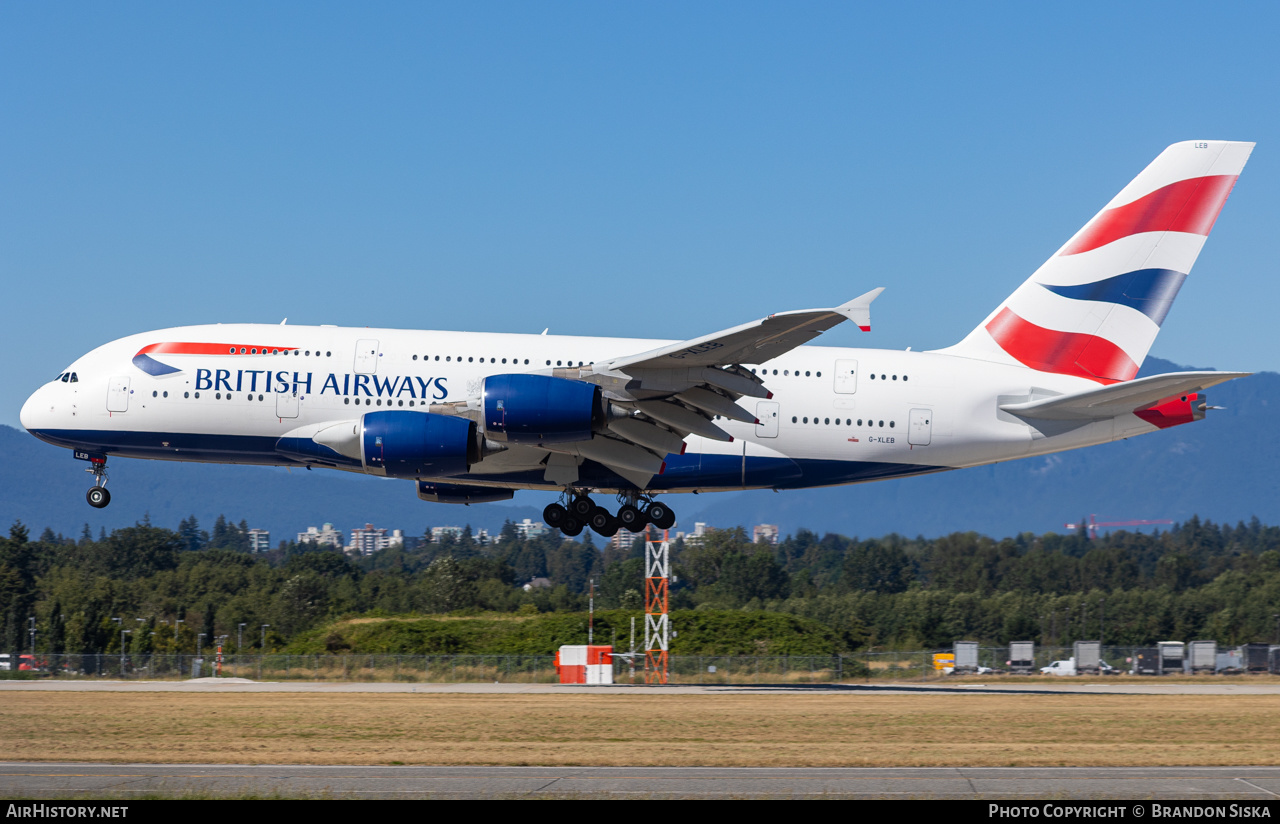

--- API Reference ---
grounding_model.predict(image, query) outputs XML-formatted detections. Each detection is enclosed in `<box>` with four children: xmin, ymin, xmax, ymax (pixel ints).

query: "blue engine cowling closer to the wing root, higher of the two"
<box><xmin>483</xmin><ymin>375</ymin><xmax>604</xmax><ymax>444</ymax></box>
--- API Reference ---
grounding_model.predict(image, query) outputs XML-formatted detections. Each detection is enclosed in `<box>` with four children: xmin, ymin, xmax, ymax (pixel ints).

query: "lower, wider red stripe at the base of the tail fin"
<box><xmin>987</xmin><ymin>307</ymin><xmax>1138</xmax><ymax>384</ymax></box>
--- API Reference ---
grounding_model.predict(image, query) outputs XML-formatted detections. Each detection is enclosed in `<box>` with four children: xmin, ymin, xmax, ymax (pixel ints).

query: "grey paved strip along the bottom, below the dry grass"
<box><xmin>0</xmin><ymin>761</ymin><xmax>1280</xmax><ymax>806</ymax></box>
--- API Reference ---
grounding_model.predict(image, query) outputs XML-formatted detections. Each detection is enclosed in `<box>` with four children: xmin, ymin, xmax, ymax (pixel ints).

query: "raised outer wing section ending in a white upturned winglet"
<box><xmin>595</xmin><ymin>287</ymin><xmax>884</xmax><ymax>371</ymax></box>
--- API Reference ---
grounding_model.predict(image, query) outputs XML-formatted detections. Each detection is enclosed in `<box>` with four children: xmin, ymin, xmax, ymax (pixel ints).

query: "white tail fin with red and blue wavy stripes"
<box><xmin>942</xmin><ymin>141</ymin><xmax>1253</xmax><ymax>384</ymax></box>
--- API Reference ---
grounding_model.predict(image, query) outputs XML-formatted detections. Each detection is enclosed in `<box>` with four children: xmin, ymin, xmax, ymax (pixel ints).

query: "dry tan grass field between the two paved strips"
<box><xmin>0</xmin><ymin>692</ymin><xmax>1280</xmax><ymax>766</ymax></box>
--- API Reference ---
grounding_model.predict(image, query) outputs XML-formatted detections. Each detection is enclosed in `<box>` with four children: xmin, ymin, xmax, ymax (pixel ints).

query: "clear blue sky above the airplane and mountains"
<box><xmin>0</xmin><ymin>0</ymin><xmax>1280</xmax><ymax>426</ymax></box>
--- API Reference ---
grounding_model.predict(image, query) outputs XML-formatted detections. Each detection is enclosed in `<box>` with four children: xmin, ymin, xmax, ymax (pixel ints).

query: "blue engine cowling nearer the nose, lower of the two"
<box><xmin>361</xmin><ymin>411</ymin><xmax>480</xmax><ymax>477</ymax></box>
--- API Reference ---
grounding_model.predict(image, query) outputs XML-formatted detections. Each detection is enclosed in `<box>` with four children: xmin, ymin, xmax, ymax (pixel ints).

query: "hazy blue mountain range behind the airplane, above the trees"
<box><xmin>0</xmin><ymin>358</ymin><xmax>1280</xmax><ymax>543</ymax></box>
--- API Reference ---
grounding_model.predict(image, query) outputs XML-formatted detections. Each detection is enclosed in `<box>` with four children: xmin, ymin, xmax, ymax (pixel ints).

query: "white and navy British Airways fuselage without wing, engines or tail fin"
<box><xmin>22</xmin><ymin>324</ymin><xmax>1156</xmax><ymax>491</ymax></box>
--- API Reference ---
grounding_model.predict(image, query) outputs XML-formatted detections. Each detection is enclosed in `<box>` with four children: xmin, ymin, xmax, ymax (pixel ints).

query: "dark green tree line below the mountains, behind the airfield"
<box><xmin>0</xmin><ymin>517</ymin><xmax>1280</xmax><ymax>654</ymax></box>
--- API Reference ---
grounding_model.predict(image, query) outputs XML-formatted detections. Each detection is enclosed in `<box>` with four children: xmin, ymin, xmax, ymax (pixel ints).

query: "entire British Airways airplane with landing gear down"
<box><xmin>20</xmin><ymin>141</ymin><xmax>1253</xmax><ymax>536</ymax></box>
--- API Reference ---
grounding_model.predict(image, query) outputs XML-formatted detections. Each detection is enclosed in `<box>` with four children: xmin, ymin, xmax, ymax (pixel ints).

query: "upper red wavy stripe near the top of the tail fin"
<box><xmin>1059</xmin><ymin>174</ymin><xmax>1236</xmax><ymax>255</ymax></box>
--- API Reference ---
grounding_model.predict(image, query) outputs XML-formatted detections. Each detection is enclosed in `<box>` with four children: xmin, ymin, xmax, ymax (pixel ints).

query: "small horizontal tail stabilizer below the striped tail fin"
<box><xmin>1000</xmin><ymin>372</ymin><xmax>1251</xmax><ymax>421</ymax></box>
